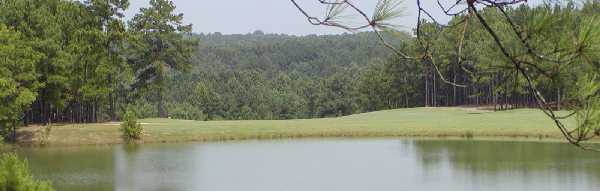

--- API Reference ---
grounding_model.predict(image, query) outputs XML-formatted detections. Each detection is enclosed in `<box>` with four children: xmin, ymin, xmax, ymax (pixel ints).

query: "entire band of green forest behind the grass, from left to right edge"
<box><xmin>0</xmin><ymin>0</ymin><xmax>600</xmax><ymax>140</ymax></box>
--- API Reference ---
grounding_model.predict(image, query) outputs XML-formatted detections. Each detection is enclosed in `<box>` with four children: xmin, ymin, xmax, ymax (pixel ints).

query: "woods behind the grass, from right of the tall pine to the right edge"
<box><xmin>155</xmin><ymin>1</ymin><xmax>600</xmax><ymax>120</ymax></box>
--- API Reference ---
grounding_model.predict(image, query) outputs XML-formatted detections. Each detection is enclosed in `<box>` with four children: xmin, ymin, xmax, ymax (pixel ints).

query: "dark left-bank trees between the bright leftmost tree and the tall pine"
<box><xmin>0</xmin><ymin>0</ymin><xmax>131</xmax><ymax>123</ymax></box>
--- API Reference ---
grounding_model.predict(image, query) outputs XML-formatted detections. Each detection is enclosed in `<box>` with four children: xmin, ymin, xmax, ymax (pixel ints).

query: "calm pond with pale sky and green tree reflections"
<box><xmin>8</xmin><ymin>139</ymin><xmax>600</xmax><ymax>191</ymax></box>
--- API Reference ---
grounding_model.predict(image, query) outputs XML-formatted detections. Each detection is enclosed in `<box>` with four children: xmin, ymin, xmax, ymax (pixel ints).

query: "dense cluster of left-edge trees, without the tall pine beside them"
<box><xmin>0</xmin><ymin>0</ymin><xmax>134</xmax><ymax>126</ymax></box>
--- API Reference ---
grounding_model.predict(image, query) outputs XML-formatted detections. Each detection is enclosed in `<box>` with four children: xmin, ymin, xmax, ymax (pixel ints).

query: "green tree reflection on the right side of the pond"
<box><xmin>404</xmin><ymin>140</ymin><xmax>600</xmax><ymax>190</ymax></box>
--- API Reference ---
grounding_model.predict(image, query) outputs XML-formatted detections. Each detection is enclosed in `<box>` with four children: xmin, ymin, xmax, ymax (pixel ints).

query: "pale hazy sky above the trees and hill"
<box><xmin>126</xmin><ymin>0</ymin><xmax>548</xmax><ymax>35</ymax></box>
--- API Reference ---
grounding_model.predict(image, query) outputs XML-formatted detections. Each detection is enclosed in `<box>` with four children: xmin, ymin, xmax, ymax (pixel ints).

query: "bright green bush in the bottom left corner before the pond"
<box><xmin>0</xmin><ymin>153</ymin><xmax>54</xmax><ymax>191</ymax></box>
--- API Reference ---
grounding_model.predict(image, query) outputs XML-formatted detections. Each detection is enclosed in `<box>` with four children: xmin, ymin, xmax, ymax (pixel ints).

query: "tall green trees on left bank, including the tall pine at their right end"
<box><xmin>0</xmin><ymin>0</ymin><xmax>197</xmax><ymax>139</ymax></box>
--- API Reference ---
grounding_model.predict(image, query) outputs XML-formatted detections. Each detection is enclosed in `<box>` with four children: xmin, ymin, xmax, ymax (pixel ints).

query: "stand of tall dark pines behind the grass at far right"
<box><xmin>416</xmin><ymin>1</ymin><xmax>600</xmax><ymax>109</ymax></box>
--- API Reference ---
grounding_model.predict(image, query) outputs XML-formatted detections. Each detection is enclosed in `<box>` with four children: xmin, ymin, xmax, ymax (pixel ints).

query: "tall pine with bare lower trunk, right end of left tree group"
<box><xmin>129</xmin><ymin>0</ymin><xmax>197</xmax><ymax>117</ymax></box>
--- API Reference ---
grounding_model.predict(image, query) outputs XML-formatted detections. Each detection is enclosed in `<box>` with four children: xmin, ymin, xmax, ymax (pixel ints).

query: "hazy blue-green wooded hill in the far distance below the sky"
<box><xmin>196</xmin><ymin>31</ymin><xmax>410</xmax><ymax>77</ymax></box>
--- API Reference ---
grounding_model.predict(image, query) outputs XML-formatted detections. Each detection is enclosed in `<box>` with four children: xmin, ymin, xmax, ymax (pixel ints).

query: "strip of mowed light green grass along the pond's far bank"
<box><xmin>20</xmin><ymin>108</ymin><xmax>574</xmax><ymax>146</ymax></box>
